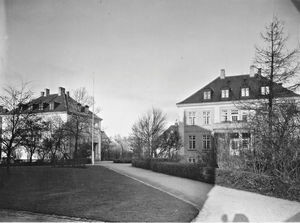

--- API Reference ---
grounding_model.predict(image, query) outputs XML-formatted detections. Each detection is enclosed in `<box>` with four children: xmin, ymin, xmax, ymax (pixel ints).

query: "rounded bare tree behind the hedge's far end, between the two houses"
<box><xmin>131</xmin><ymin>108</ymin><xmax>166</xmax><ymax>158</ymax></box>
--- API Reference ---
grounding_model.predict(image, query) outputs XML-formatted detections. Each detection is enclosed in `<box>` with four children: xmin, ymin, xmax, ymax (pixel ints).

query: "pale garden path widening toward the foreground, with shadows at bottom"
<box><xmin>97</xmin><ymin>161</ymin><xmax>300</xmax><ymax>222</ymax></box>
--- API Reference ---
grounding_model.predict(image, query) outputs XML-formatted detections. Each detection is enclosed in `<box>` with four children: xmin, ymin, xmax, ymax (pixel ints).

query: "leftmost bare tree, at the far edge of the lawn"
<box><xmin>0</xmin><ymin>84</ymin><xmax>33</xmax><ymax>169</ymax></box>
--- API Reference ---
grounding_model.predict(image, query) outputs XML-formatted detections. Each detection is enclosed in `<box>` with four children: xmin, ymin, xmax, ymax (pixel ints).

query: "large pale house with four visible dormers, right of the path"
<box><xmin>177</xmin><ymin>66</ymin><xmax>300</xmax><ymax>162</ymax></box>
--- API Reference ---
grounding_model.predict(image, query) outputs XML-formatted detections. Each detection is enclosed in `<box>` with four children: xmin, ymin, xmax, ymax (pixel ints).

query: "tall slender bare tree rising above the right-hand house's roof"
<box><xmin>255</xmin><ymin>17</ymin><xmax>300</xmax><ymax>131</ymax></box>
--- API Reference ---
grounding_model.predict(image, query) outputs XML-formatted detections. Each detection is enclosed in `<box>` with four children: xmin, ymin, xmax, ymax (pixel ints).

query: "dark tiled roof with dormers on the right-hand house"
<box><xmin>177</xmin><ymin>74</ymin><xmax>299</xmax><ymax>105</ymax></box>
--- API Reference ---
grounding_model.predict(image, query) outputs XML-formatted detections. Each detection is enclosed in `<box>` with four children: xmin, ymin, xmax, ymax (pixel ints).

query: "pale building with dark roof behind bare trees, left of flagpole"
<box><xmin>0</xmin><ymin>87</ymin><xmax>102</xmax><ymax>160</ymax></box>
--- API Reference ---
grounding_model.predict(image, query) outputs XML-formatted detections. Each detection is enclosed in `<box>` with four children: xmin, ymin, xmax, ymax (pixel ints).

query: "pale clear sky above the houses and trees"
<box><xmin>0</xmin><ymin>0</ymin><xmax>300</xmax><ymax>136</ymax></box>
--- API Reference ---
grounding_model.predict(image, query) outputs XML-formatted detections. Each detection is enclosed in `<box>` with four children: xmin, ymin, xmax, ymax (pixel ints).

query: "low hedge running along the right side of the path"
<box><xmin>132</xmin><ymin>160</ymin><xmax>300</xmax><ymax>201</ymax></box>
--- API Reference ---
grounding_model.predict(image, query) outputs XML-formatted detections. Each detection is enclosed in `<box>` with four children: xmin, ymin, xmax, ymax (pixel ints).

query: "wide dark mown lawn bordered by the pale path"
<box><xmin>0</xmin><ymin>166</ymin><xmax>198</xmax><ymax>222</ymax></box>
